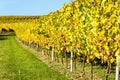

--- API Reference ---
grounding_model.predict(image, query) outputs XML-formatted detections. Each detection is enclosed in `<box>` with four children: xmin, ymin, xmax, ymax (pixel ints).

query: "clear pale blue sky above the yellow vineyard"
<box><xmin>0</xmin><ymin>0</ymin><xmax>71</xmax><ymax>16</ymax></box>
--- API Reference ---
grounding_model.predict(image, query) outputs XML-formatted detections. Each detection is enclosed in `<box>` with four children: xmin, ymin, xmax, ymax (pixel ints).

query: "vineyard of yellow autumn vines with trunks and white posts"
<box><xmin>0</xmin><ymin>0</ymin><xmax>120</xmax><ymax>80</ymax></box>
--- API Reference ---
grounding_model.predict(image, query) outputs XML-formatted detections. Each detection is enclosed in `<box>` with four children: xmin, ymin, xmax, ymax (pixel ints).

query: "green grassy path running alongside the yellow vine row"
<box><xmin>0</xmin><ymin>36</ymin><xmax>67</xmax><ymax>80</ymax></box>
